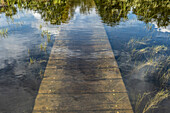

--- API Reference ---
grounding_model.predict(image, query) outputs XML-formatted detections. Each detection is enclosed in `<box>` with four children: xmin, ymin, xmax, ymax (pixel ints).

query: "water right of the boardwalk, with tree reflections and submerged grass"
<box><xmin>95</xmin><ymin>0</ymin><xmax>170</xmax><ymax>113</ymax></box>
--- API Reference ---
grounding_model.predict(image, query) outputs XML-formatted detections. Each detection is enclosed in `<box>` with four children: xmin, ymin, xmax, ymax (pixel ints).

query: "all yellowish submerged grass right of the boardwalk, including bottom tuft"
<box><xmin>127</xmin><ymin>35</ymin><xmax>170</xmax><ymax>113</ymax></box>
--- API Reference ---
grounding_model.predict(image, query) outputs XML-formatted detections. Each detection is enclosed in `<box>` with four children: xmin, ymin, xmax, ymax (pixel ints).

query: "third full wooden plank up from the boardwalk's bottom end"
<box><xmin>43</xmin><ymin>68</ymin><xmax>122</xmax><ymax>81</ymax></box>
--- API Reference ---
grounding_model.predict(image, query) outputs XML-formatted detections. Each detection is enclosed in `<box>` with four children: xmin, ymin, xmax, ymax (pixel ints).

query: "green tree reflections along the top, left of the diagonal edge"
<box><xmin>0</xmin><ymin>0</ymin><xmax>94</xmax><ymax>25</ymax></box>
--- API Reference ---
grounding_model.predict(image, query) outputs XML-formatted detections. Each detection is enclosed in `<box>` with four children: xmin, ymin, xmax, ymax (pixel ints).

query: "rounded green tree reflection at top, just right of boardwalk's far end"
<box><xmin>95</xmin><ymin>0</ymin><xmax>131</xmax><ymax>26</ymax></box>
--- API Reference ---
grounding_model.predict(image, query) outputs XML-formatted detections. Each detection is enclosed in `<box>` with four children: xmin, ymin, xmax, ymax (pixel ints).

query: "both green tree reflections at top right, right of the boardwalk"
<box><xmin>95</xmin><ymin>0</ymin><xmax>170</xmax><ymax>27</ymax></box>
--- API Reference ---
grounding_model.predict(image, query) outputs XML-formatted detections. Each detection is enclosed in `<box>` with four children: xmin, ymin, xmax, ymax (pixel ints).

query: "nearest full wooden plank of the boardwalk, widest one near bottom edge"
<box><xmin>35</xmin><ymin>93</ymin><xmax>131</xmax><ymax>111</ymax></box>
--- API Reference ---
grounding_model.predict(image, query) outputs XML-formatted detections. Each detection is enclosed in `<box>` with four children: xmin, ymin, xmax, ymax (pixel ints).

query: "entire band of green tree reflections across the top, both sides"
<box><xmin>0</xmin><ymin>0</ymin><xmax>170</xmax><ymax>27</ymax></box>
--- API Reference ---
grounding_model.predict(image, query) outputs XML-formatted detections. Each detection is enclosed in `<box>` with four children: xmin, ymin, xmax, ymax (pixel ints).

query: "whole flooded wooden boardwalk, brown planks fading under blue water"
<box><xmin>33</xmin><ymin>3</ymin><xmax>133</xmax><ymax>113</ymax></box>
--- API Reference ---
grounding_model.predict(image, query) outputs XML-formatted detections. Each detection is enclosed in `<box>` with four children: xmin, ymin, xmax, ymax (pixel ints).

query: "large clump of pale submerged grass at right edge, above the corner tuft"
<box><xmin>127</xmin><ymin>37</ymin><xmax>170</xmax><ymax>92</ymax></box>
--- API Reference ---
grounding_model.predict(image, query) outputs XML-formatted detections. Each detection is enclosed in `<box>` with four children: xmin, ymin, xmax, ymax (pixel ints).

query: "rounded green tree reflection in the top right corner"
<box><xmin>133</xmin><ymin>0</ymin><xmax>170</xmax><ymax>27</ymax></box>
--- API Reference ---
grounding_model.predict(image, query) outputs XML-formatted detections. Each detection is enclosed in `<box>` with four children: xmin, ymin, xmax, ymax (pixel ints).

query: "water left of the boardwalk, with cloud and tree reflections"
<box><xmin>0</xmin><ymin>0</ymin><xmax>97</xmax><ymax>113</ymax></box>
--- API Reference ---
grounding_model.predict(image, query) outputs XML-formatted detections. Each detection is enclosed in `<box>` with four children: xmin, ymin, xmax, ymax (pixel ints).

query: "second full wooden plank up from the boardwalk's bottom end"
<box><xmin>36</xmin><ymin>79</ymin><xmax>126</xmax><ymax>94</ymax></box>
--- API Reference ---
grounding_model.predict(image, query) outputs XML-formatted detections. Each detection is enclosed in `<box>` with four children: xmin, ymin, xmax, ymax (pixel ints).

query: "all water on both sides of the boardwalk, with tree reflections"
<box><xmin>0</xmin><ymin>0</ymin><xmax>170</xmax><ymax>113</ymax></box>
